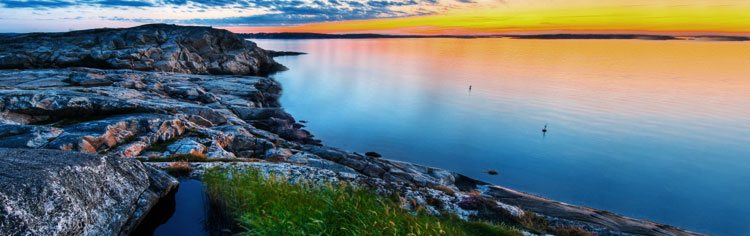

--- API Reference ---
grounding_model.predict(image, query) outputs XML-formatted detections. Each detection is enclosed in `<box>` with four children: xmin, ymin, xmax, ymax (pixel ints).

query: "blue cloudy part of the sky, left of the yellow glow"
<box><xmin>0</xmin><ymin>0</ymin><xmax>474</xmax><ymax>32</ymax></box>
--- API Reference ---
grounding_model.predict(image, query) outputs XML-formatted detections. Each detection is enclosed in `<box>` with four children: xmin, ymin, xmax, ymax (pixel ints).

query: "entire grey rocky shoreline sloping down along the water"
<box><xmin>0</xmin><ymin>25</ymin><xmax>697</xmax><ymax>235</ymax></box>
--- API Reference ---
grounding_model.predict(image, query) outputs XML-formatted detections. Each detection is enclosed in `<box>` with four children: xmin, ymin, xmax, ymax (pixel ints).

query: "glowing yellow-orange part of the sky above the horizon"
<box><xmin>230</xmin><ymin>0</ymin><xmax>750</xmax><ymax>35</ymax></box>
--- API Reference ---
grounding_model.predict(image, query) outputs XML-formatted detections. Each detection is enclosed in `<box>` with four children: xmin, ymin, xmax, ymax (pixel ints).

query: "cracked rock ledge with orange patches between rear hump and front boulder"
<box><xmin>0</xmin><ymin>68</ymin><xmax>314</xmax><ymax>158</ymax></box>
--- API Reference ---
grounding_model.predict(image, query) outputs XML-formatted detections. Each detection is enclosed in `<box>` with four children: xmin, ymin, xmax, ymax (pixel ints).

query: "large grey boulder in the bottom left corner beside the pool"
<box><xmin>0</xmin><ymin>148</ymin><xmax>177</xmax><ymax>235</ymax></box>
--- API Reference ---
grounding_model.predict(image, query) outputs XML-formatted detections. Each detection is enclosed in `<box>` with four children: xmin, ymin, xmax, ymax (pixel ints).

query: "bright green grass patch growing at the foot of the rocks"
<box><xmin>203</xmin><ymin>169</ymin><xmax>521</xmax><ymax>235</ymax></box>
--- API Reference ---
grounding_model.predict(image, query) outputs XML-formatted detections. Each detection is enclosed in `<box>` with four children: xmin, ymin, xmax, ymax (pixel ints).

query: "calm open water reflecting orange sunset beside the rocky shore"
<box><xmin>254</xmin><ymin>39</ymin><xmax>750</xmax><ymax>235</ymax></box>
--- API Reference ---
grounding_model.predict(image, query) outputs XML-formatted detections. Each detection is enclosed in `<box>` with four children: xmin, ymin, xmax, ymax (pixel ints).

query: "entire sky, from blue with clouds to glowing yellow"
<box><xmin>0</xmin><ymin>0</ymin><xmax>750</xmax><ymax>35</ymax></box>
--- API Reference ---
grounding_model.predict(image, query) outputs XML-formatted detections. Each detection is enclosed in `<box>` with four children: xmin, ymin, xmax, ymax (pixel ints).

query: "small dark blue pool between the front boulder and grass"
<box><xmin>132</xmin><ymin>178</ymin><xmax>209</xmax><ymax>236</ymax></box>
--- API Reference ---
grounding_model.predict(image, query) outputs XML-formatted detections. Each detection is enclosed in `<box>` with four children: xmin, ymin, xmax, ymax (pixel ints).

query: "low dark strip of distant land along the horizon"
<box><xmin>239</xmin><ymin>33</ymin><xmax>750</xmax><ymax>41</ymax></box>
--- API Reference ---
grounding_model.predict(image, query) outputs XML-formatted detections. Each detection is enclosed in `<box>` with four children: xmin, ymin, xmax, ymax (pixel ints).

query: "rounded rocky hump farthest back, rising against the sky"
<box><xmin>0</xmin><ymin>24</ymin><xmax>285</xmax><ymax>75</ymax></box>
